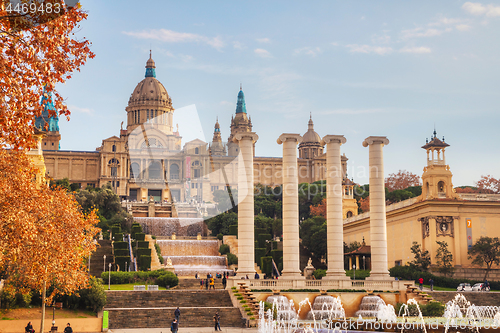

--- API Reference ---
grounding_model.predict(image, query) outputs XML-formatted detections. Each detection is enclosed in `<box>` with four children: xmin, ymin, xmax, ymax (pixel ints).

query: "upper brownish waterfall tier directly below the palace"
<box><xmin>134</xmin><ymin>217</ymin><xmax>207</xmax><ymax>237</ymax></box>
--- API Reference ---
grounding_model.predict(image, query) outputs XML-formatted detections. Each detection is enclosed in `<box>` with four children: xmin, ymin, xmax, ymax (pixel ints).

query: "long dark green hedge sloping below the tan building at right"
<box><xmin>389</xmin><ymin>266</ymin><xmax>500</xmax><ymax>290</ymax></box>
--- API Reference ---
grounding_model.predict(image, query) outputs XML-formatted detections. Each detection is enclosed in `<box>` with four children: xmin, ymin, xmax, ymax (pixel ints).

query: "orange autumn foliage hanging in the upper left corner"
<box><xmin>0</xmin><ymin>0</ymin><xmax>94</xmax><ymax>148</ymax></box>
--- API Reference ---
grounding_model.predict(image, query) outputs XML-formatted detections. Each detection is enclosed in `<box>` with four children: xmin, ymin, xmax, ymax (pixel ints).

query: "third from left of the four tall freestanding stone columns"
<box><xmin>322</xmin><ymin>135</ymin><xmax>349</xmax><ymax>280</ymax></box>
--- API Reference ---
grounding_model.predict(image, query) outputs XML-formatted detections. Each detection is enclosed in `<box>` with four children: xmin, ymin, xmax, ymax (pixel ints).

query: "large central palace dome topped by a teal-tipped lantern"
<box><xmin>125</xmin><ymin>53</ymin><xmax>174</xmax><ymax>135</ymax></box>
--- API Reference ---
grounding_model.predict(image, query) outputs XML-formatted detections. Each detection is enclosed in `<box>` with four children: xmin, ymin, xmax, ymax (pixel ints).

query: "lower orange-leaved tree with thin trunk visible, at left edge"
<box><xmin>0</xmin><ymin>149</ymin><xmax>99</xmax><ymax>332</ymax></box>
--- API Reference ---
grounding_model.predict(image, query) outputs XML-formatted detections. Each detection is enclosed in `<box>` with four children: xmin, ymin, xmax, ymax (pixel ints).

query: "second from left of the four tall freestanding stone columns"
<box><xmin>278</xmin><ymin>133</ymin><xmax>302</xmax><ymax>279</ymax></box>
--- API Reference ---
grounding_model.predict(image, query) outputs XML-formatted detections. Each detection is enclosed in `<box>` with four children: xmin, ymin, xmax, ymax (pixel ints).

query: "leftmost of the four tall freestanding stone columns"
<box><xmin>233</xmin><ymin>132</ymin><xmax>259</xmax><ymax>278</ymax></box>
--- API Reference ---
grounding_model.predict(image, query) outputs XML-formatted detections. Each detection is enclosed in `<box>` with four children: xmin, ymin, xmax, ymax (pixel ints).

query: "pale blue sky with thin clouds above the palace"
<box><xmin>59</xmin><ymin>0</ymin><xmax>500</xmax><ymax>186</ymax></box>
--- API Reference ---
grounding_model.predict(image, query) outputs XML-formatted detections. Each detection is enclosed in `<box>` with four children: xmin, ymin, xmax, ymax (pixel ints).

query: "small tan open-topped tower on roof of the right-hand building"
<box><xmin>422</xmin><ymin>130</ymin><xmax>457</xmax><ymax>200</ymax></box>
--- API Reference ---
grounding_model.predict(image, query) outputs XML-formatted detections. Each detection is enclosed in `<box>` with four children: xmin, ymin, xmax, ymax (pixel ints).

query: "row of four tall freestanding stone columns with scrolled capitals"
<box><xmin>234</xmin><ymin>132</ymin><xmax>391</xmax><ymax>280</ymax></box>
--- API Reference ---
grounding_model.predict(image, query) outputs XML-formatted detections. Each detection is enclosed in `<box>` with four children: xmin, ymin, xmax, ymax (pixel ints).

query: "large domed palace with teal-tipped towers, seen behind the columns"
<box><xmin>40</xmin><ymin>55</ymin><xmax>358</xmax><ymax>216</ymax></box>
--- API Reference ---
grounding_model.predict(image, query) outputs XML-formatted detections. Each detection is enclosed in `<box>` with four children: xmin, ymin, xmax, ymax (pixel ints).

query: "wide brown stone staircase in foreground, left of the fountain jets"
<box><xmin>104</xmin><ymin>290</ymin><xmax>243</xmax><ymax>329</ymax></box>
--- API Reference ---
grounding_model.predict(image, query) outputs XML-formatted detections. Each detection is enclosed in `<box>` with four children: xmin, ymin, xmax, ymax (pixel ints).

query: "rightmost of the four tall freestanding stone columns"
<box><xmin>363</xmin><ymin>136</ymin><xmax>392</xmax><ymax>280</ymax></box>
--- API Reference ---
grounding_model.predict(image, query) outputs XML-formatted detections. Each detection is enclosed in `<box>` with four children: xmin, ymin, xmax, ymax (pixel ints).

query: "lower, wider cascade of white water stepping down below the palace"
<box><xmin>156</xmin><ymin>239</ymin><xmax>230</xmax><ymax>275</ymax></box>
